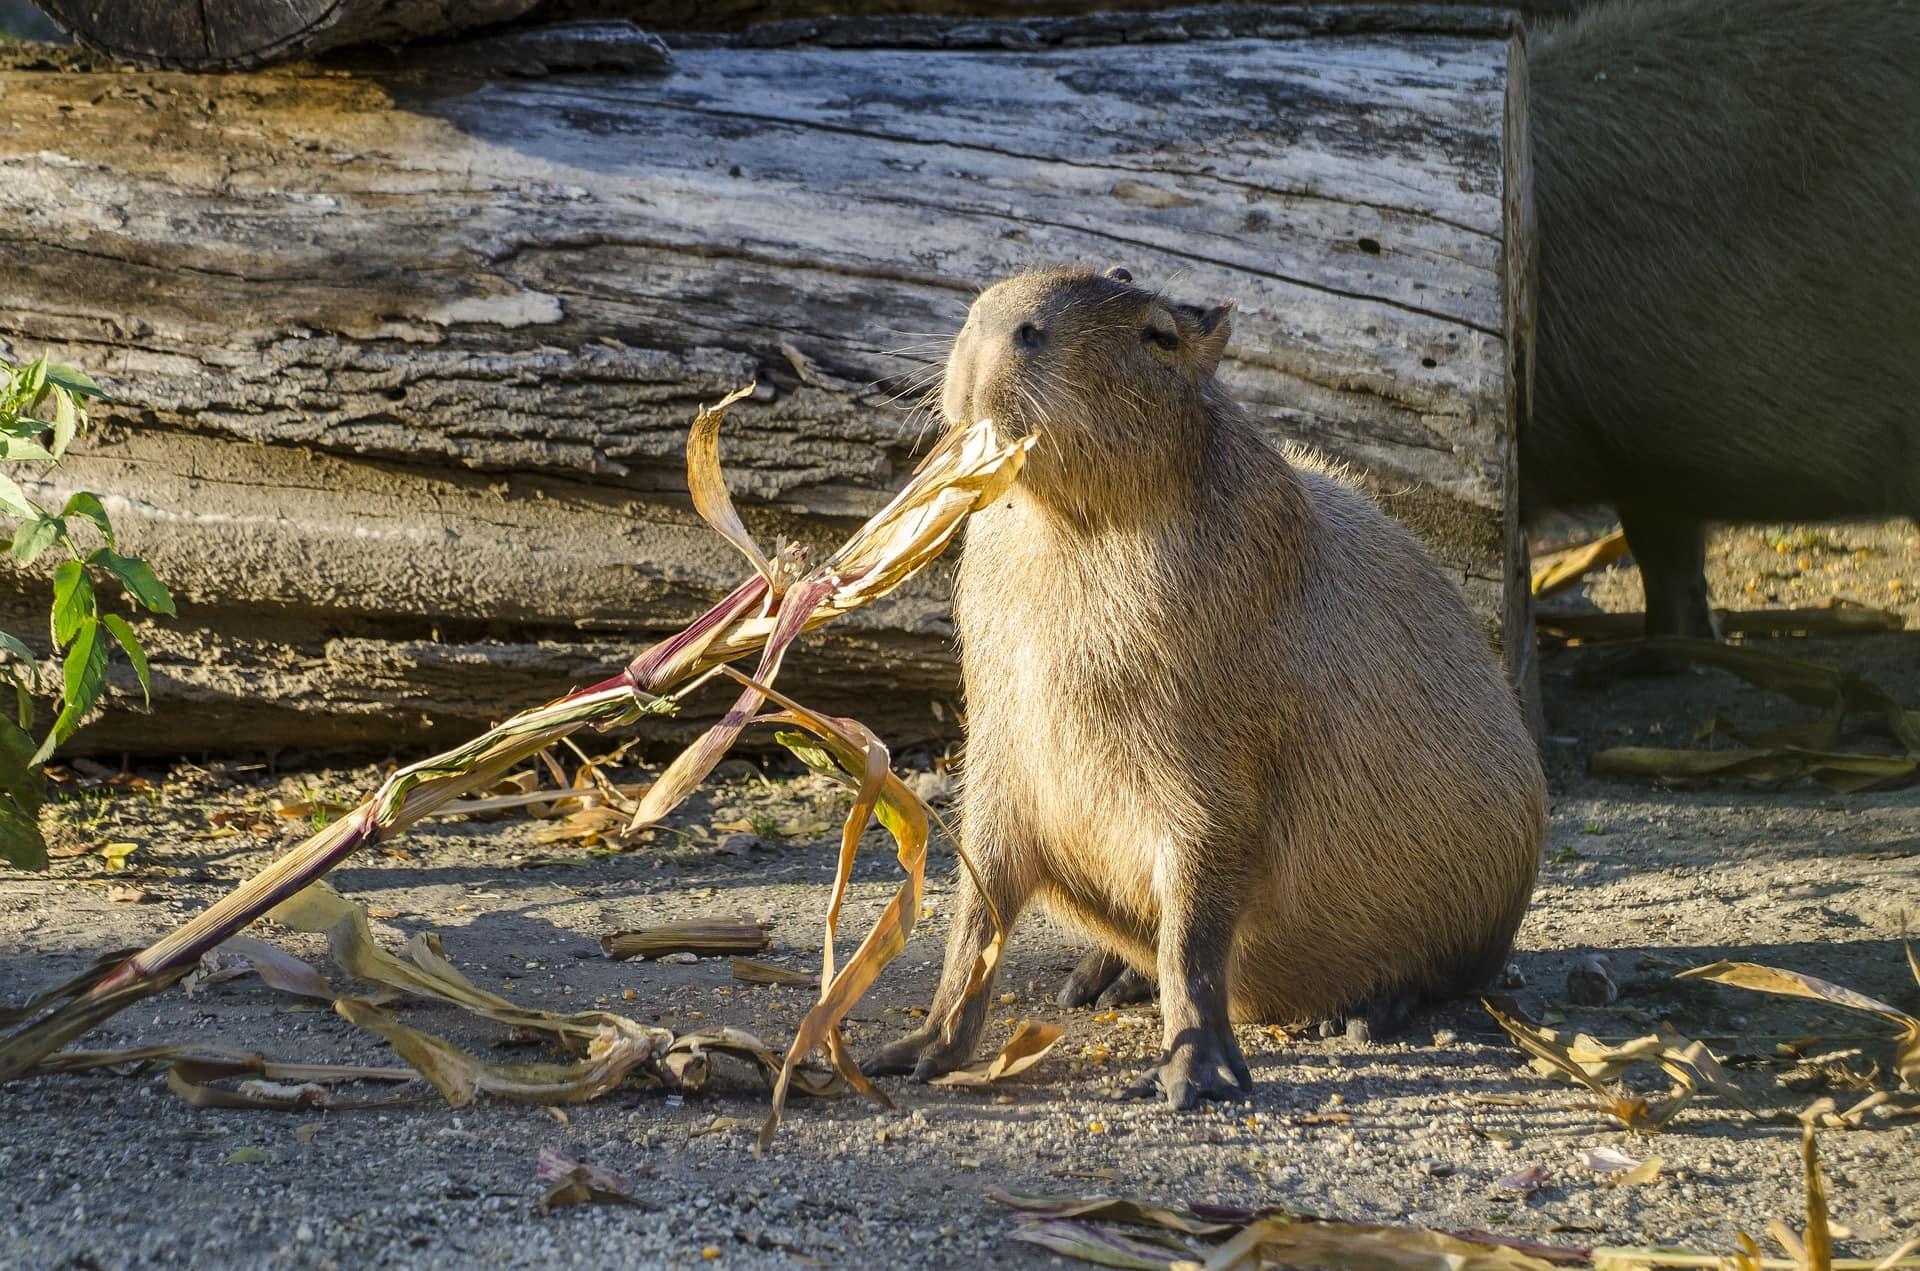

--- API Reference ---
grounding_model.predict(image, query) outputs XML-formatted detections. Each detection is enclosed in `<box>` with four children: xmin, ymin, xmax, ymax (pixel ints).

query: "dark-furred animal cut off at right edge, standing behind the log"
<box><xmin>1521</xmin><ymin>0</ymin><xmax>1920</xmax><ymax>636</ymax></box>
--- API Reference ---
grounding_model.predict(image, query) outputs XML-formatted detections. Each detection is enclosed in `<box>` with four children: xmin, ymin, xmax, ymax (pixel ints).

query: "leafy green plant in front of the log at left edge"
<box><xmin>0</xmin><ymin>357</ymin><xmax>173</xmax><ymax>870</ymax></box>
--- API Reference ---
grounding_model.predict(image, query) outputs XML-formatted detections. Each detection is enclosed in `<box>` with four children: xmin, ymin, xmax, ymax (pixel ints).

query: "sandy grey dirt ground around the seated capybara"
<box><xmin>0</xmin><ymin>522</ymin><xmax>1920</xmax><ymax>1267</ymax></box>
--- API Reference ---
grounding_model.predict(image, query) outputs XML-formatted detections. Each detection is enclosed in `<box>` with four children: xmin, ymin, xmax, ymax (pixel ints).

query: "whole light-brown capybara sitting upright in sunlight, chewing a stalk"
<box><xmin>872</xmin><ymin>271</ymin><xmax>1546</xmax><ymax>1104</ymax></box>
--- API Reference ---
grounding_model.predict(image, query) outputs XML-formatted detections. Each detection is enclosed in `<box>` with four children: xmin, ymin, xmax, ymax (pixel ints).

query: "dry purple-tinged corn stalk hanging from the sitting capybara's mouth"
<box><xmin>0</xmin><ymin>390</ymin><xmax>1035</xmax><ymax>1117</ymax></box>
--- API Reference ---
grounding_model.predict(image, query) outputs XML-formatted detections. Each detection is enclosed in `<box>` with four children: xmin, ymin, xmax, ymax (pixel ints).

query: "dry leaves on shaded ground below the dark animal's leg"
<box><xmin>1590</xmin><ymin>636</ymin><xmax>1920</xmax><ymax>793</ymax></box>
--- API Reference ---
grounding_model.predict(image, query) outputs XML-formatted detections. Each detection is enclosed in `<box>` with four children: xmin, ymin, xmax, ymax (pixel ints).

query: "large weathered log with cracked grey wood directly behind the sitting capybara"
<box><xmin>0</xmin><ymin>10</ymin><xmax>1528</xmax><ymax>751</ymax></box>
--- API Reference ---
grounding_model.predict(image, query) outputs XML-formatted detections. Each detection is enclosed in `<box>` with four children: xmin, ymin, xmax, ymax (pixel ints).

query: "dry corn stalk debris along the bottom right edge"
<box><xmin>987</xmin><ymin>1129</ymin><xmax>1920</xmax><ymax>1271</ymax></box>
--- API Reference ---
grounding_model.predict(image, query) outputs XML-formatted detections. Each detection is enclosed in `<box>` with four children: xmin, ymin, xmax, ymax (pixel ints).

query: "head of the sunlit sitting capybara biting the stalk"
<box><xmin>941</xmin><ymin>269</ymin><xmax>1233</xmax><ymax>505</ymax></box>
